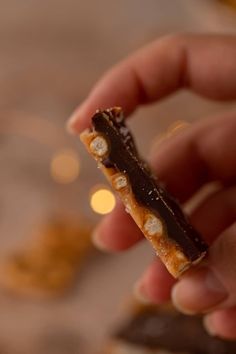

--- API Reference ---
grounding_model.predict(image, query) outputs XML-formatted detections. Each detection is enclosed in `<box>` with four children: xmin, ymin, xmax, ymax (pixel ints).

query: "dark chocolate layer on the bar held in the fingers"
<box><xmin>92</xmin><ymin>110</ymin><xmax>207</xmax><ymax>261</ymax></box>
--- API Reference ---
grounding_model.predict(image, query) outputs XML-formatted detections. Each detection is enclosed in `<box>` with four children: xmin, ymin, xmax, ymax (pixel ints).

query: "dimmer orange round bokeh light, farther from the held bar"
<box><xmin>50</xmin><ymin>149</ymin><xmax>80</xmax><ymax>184</ymax></box>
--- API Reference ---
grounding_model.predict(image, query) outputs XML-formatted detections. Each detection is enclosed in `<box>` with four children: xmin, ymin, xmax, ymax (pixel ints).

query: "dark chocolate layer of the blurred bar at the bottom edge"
<box><xmin>114</xmin><ymin>310</ymin><xmax>236</xmax><ymax>354</ymax></box>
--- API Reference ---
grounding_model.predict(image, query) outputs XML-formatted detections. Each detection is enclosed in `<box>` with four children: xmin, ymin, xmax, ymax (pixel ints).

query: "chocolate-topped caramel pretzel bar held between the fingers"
<box><xmin>81</xmin><ymin>107</ymin><xmax>207</xmax><ymax>278</ymax></box>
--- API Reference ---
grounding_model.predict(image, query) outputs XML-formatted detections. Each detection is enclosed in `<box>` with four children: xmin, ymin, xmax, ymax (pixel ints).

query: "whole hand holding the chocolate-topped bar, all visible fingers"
<box><xmin>68</xmin><ymin>34</ymin><xmax>236</xmax><ymax>339</ymax></box>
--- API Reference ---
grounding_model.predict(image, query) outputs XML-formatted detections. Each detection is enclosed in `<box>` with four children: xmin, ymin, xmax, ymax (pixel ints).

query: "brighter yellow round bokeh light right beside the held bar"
<box><xmin>90</xmin><ymin>186</ymin><xmax>116</xmax><ymax>215</ymax></box>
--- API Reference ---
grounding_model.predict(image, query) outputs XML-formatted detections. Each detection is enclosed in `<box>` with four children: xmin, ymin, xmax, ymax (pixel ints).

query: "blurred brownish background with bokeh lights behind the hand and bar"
<box><xmin>0</xmin><ymin>0</ymin><xmax>236</xmax><ymax>354</ymax></box>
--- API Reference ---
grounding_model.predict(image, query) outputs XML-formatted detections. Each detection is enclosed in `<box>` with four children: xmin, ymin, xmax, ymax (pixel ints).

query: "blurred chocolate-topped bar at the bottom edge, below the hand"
<box><xmin>104</xmin><ymin>306</ymin><xmax>236</xmax><ymax>354</ymax></box>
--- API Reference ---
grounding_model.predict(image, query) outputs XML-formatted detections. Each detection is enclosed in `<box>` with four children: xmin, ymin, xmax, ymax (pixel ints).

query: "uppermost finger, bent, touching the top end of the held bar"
<box><xmin>69</xmin><ymin>35</ymin><xmax>236</xmax><ymax>133</ymax></box>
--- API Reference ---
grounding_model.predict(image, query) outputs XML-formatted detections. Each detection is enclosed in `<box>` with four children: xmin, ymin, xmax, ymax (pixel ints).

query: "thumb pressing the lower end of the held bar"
<box><xmin>172</xmin><ymin>223</ymin><xmax>236</xmax><ymax>314</ymax></box>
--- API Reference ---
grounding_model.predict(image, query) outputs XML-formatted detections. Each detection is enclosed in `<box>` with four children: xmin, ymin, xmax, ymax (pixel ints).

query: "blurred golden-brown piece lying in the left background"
<box><xmin>0</xmin><ymin>215</ymin><xmax>92</xmax><ymax>298</ymax></box>
